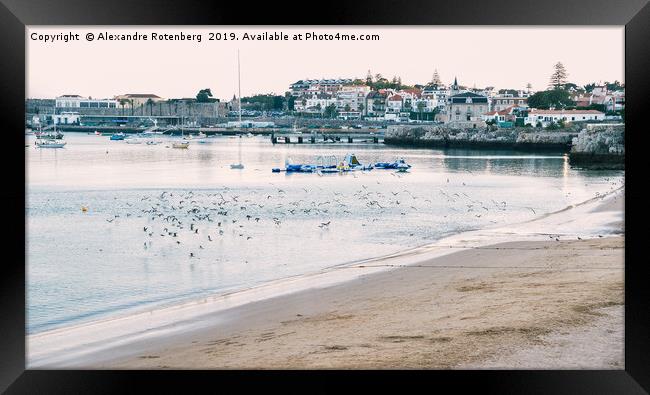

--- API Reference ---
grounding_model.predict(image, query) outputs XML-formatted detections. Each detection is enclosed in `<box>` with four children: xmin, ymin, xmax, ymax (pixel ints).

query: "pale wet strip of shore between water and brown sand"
<box><xmin>27</xmin><ymin>190</ymin><xmax>623</xmax><ymax>367</ymax></box>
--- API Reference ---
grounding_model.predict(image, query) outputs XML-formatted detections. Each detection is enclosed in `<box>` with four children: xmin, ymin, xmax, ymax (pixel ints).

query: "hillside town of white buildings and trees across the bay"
<box><xmin>26</xmin><ymin>62</ymin><xmax>625</xmax><ymax>128</ymax></box>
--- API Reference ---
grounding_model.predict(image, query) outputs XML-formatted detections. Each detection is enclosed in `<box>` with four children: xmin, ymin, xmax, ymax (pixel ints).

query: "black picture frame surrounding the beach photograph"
<box><xmin>0</xmin><ymin>0</ymin><xmax>650</xmax><ymax>394</ymax></box>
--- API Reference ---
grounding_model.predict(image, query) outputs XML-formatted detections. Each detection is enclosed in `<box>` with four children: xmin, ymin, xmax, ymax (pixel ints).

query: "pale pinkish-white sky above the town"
<box><xmin>26</xmin><ymin>26</ymin><xmax>625</xmax><ymax>99</ymax></box>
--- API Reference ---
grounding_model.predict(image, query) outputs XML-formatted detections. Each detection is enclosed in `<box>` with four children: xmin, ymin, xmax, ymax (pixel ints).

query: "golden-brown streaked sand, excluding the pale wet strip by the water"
<box><xmin>107</xmin><ymin>236</ymin><xmax>624</xmax><ymax>369</ymax></box>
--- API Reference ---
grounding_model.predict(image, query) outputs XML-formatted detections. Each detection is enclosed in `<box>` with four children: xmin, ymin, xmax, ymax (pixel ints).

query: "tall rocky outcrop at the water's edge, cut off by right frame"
<box><xmin>569</xmin><ymin>124</ymin><xmax>625</xmax><ymax>169</ymax></box>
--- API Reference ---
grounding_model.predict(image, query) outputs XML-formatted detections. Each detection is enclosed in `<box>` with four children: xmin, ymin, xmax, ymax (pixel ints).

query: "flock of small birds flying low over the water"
<box><xmin>97</xmin><ymin>172</ymin><xmax>624</xmax><ymax>258</ymax></box>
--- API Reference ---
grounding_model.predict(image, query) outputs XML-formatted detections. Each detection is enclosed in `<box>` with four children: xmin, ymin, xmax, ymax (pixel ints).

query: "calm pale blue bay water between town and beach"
<box><xmin>25</xmin><ymin>133</ymin><xmax>624</xmax><ymax>333</ymax></box>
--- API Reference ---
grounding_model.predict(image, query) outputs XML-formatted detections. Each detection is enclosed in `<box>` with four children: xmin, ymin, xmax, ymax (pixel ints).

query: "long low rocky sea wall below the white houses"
<box><xmin>384</xmin><ymin>125</ymin><xmax>580</xmax><ymax>152</ymax></box>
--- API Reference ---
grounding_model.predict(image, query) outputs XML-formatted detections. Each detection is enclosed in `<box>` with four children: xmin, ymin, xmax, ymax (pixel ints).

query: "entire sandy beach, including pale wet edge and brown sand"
<box><xmin>27</xmin><ymin>189</ymin><xmax>624</xmax><ymax>369</ymax></box>
